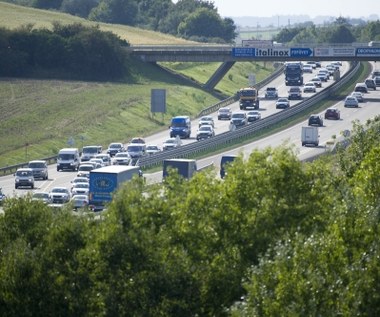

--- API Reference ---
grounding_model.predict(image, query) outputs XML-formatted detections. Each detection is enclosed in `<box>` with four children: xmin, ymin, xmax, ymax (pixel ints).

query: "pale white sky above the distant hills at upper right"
<box><xmin>211</xmin><ymin>0</ymin><xmax>380</xmax><ymax>18</ymax></box>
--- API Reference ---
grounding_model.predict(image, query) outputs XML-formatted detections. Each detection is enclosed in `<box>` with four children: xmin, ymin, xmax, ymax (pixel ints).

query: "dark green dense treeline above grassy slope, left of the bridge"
<box><xmin>0</xmin><ymin>23</ymin><xmax>129</xmax><ymax>80</ymax></box>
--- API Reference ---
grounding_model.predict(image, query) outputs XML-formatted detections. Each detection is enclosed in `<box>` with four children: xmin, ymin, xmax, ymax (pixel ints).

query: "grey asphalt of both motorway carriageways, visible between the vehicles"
<box><xmin>0</xmin><ymin>63</ymin><xmax>368</xmax><ymax>197</ymax></box>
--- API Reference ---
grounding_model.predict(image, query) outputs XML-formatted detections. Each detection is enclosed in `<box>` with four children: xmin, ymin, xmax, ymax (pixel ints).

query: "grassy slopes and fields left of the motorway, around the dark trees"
<box><xmin>0</xmin><ymin>2</ymin><xmax>273</xmax><ymax>167</ymax></box>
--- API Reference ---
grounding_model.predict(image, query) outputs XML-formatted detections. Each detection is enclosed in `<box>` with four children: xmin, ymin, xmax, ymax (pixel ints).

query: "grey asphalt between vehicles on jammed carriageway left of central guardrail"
<box><xmin>0</xmin><ymin>63</ymin><xmax>349</xmax><ymax>197</ymax></box>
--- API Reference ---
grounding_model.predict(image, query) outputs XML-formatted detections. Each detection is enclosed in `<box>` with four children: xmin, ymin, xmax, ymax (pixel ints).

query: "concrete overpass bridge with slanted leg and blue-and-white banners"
<box><xmin>126</xmin><ymin>43</ymin><xmax>380</xmax><ymax>89</ymax></box>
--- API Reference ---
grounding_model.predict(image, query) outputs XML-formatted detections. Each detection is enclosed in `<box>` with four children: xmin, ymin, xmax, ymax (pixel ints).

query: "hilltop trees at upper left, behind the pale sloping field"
<box><xmin>2</xmin><ymin>0</ymin><xmax>236</xmax><ymax>43</ymax></box>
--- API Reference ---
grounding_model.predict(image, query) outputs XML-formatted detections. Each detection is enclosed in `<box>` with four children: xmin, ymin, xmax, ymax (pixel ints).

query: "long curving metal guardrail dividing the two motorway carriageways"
<box><xmin>140</xmin><ymin>62</ymin><xmax>360</xmax><ymax>168</ymax></box>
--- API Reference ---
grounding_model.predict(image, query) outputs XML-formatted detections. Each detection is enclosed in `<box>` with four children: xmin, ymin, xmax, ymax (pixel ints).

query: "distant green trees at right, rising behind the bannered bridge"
<box><xmin>274</xmin><ymin>17</ymin><xmax>380</xmax><ymax>44</ymax></box>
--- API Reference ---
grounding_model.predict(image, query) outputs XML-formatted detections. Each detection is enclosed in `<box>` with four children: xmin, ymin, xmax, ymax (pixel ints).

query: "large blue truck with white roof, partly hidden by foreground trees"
<box><xmin>89</xmin><ymin>165</ymin><xmax>141</xmax><ymax>211</ymax></box>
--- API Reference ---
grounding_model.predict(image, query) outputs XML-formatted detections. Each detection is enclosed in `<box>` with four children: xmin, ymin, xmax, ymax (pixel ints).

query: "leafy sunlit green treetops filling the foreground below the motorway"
<box><xmin>0</xmin><ymin>118</ymin><xmax>380</xmax><ymax>317</ymax></box>
